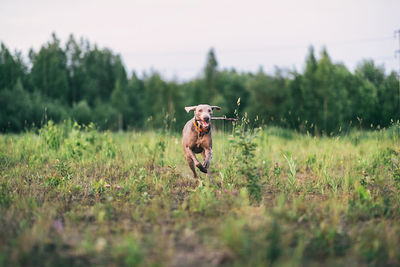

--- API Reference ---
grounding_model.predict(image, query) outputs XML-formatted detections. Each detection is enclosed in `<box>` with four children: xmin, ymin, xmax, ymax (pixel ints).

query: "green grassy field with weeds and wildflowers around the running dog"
<box><xmin>0</xmin><ymin>123</ymin><xmax>400</xmax><ymax>266</ymax></box>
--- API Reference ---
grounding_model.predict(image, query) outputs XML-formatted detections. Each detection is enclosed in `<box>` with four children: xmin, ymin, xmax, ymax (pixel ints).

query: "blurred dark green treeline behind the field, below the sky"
<box><xmin>0</xmin><ymin>34</ymin><xmax>400</xmax><ymax>134</ymax></box>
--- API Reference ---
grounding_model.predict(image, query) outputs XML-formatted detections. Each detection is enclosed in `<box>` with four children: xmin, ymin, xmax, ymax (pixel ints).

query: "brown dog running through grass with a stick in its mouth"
<box><xmin>182</xmin><ymin>105</ymin><xmax>221</xmax><ymax>178</ymax></box>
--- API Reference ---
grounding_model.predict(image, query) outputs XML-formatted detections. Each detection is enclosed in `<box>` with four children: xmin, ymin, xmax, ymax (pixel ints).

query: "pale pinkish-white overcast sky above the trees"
<box><xmin>0</xmin><ymin>0</ymin><xmax>400</xmax><ymax>80</ymax></box>
